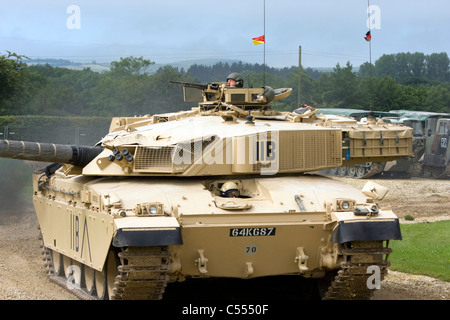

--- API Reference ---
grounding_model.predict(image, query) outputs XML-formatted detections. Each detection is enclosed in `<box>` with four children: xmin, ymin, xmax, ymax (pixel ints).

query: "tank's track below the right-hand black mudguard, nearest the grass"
<box><xmin>323</xmin><ymin>241</ymin><xmax>392</xmax><ymax>300</ymax></box>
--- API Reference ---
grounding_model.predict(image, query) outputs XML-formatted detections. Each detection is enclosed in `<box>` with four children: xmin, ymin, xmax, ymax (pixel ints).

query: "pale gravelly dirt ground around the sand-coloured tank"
<box><xmin>0</xmin><ymin>178</ymin><xmax>450</xmax><ymax>300</ymax></box>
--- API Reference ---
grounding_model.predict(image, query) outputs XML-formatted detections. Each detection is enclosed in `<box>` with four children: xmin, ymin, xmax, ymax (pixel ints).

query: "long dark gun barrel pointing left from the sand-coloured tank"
<box><xmin>0</xmin><ymin>140</ymin><xmax>103</xmax><ymax>167</ymax></box>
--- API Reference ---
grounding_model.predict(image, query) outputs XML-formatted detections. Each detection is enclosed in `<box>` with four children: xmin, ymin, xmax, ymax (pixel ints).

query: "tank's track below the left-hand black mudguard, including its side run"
<box><xmin>40</xmin><ymin>230</ymin><xmax>171</xmax><ymax>300</ymax></box>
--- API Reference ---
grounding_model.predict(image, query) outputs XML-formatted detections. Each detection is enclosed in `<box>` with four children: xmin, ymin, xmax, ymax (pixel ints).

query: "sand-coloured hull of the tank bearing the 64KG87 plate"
<box><xmin>34</xmin><ymin>169</ymin><xmax>401</xmax><ymax>299</ymax></box>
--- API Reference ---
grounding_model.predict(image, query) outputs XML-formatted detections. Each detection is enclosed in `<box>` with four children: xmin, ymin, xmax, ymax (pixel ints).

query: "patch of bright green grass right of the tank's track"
<box><xmin>389</xmin><ymin>220</ymin><xmax>450</xmax><ymax>282</ymax></box>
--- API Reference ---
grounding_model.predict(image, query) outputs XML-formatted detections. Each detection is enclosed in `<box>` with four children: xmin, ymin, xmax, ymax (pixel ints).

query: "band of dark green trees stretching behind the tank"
<box><xmin>0</xmin><ymin>52</ymin><xmax>450</xmax><ymax>117</ymax></box>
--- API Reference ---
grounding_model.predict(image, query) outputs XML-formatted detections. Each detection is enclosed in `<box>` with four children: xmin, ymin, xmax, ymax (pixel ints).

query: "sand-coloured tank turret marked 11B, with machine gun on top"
<box><xmin>83</xmin><ymin>94</ymin><xmax>412</xmax><ymax>177</ymax></box>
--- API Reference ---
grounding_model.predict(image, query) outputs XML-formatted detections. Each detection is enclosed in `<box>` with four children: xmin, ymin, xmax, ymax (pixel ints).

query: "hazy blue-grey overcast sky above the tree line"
<box><xmin>0</xmin><ymin>0</ymin><xmax>450</xmax><ymax>67</ymax></box>
